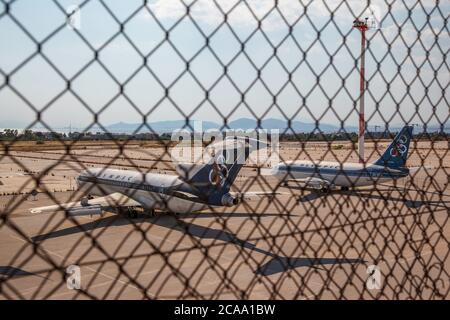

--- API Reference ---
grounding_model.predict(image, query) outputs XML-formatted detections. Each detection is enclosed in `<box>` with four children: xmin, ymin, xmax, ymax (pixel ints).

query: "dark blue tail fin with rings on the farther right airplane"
<box><xmin>375</xmin><ymin>126</ymin><xmax>413</xmax><ymax>168</ymax></box>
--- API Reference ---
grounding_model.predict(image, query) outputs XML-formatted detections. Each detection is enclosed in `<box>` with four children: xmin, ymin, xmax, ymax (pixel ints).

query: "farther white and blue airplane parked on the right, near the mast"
<box><xmin>268</xmin><ymin>126</ymin><xmax>413</xmax><ymax>192</ymax></box>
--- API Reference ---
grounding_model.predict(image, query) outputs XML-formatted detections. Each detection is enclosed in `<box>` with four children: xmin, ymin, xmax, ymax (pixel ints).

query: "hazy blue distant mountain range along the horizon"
<box><xmin>0</xmin><ymin>118</ymin><xmax>450</xmax><ymax>133</ymax></box>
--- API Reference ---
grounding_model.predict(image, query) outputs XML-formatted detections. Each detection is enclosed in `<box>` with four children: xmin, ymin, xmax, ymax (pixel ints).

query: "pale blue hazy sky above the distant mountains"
<box><xmin>0</xmin><ymin>0</ymin><xmax>450</xmax><ymax>128</ymax></box>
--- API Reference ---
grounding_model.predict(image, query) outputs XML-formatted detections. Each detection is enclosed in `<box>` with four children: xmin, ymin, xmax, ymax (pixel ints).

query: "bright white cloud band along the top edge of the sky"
<box><xmin>144</xmin><ymin>0</ymin><xmax>432</xmax><ymax>30</ymax></box>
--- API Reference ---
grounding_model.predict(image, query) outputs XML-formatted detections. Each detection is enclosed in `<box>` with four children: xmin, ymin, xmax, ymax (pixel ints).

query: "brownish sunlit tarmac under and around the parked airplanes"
<box><xmin>0</xmin><ymin>144</ymin><xmax>450</xmax><ymax>299</ymax></box>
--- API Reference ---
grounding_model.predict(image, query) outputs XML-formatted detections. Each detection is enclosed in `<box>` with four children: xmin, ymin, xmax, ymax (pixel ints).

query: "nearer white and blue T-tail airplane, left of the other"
<box><xmin>30</xmin><ymin>137</ymin><xmax>274</xmax><ymax>218</ymax></box>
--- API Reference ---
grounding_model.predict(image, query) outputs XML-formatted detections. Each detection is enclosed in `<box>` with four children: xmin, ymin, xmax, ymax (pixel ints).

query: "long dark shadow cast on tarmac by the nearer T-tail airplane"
<box><xmin>31</xmin><ymin>213</ymin><xmax>365</xmax><ymax>276</ymax></box>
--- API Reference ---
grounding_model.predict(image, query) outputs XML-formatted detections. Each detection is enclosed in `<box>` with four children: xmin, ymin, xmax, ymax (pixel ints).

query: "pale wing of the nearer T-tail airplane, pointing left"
<box><xmin>30</xmin><ymin>192</ymin><xmax>141</xmax><ymax>213</ymax></box>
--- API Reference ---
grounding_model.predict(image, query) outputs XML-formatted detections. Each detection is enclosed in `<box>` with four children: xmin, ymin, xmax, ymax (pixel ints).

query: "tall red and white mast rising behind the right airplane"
<box><xmin>353</xmin><ymin>18</ymin><xmax>369</xmax><ymax>163</ymax></box>
